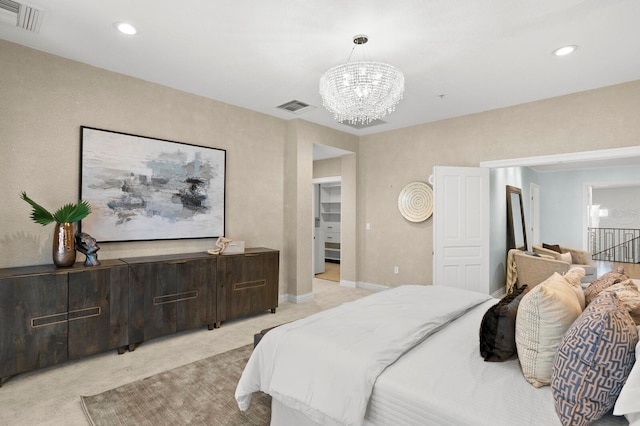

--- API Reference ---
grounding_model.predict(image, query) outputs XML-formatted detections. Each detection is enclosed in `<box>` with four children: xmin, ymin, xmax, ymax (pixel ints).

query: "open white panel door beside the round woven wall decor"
<box><xmin>433</xmin><ymin>166</ymin><xmax>490</xmax><ymax>294</ymax></box>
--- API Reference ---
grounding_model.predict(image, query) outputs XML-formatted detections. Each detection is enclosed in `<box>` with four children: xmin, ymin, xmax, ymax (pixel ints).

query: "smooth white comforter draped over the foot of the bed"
<box><xmin>236</xmin><ymin>286</ymin><xmax>490</xmax><ymax>425</ymax></box>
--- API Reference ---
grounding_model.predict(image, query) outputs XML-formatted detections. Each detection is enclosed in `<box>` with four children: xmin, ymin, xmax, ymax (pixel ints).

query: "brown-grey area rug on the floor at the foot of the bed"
<box><xmin>81</xmin><ymin>345</ymin><xmax>271</xmax><ymax>426</ymax></box>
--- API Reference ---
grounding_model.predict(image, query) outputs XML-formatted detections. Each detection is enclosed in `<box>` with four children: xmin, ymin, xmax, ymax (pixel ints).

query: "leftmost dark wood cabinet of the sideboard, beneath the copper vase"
<box><xmin>0</xmin><ymin>260</ymin><xmax>129</xmax><ymax>385</ymax></box>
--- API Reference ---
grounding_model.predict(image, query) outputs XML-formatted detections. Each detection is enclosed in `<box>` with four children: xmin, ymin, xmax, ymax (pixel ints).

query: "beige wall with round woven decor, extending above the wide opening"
<box><xmin>357</xmin><ymin>81</ymin><xmax>640</xmax><ymax>286</ymax></box>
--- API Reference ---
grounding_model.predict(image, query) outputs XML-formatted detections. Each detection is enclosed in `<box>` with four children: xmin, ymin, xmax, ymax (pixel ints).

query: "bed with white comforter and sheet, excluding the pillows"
<box><xmin>236</xmin><ymin>286</ymin><xmax>628</xmax><ymax>426</ymax></box>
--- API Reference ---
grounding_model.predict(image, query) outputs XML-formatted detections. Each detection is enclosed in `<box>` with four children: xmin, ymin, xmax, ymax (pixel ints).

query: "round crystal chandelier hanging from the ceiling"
<box><xmin>320</xmin><ymin>35</ymin><xmax>404</xmax><ymax>124</ymax></box>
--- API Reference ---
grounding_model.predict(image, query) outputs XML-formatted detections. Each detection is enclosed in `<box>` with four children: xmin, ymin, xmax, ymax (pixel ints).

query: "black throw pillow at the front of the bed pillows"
<box><xmin>480</xmin><ymin>285</ymin><xmax>527</xmax><ymax>362</ymax></box>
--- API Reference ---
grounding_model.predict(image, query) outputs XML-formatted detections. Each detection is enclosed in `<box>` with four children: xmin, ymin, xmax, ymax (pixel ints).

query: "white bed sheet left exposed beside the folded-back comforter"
<box><xmin>271</xmin><ymin>300</ymin><xmax>628</xmax><ymax>426</ymax></box>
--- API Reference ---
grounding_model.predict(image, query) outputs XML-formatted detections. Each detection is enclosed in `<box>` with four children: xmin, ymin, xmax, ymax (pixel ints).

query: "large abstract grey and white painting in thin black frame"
<box><xmin>80</xmin><ymin>126</ymin><xmax>226</xmax><ymax>242</ymax></box>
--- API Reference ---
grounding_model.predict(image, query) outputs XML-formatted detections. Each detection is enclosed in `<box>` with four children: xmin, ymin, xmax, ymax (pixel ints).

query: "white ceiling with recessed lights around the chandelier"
<box><xmin>0</xmin><ymin>0</ymin><xmax>640</xmax><ymax>139</ymax></box>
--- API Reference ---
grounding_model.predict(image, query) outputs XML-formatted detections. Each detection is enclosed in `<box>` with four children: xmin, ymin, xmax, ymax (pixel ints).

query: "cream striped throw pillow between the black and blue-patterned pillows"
<box><xmin>516</xmin><ymin>272</ymin><xmax>582</xmax><ymax>387</ymax></box>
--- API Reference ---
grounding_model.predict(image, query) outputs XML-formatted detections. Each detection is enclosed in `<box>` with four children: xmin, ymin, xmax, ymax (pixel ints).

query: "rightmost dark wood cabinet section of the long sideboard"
<box><xmin>217</xmin><ymin>247</ymin><xmax>280</xmax><ymax>321</ymax></box>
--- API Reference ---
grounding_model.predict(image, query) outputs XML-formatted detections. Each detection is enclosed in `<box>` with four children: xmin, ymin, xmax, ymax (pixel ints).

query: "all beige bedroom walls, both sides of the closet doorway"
<box><xmin>0</xmin><ymin>41</ymin><xmax>640</xmax><ymax>296</ymax></box>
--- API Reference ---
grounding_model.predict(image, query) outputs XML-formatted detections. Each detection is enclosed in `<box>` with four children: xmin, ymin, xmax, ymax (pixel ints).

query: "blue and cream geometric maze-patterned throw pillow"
<box><xmin>551</xmin><ymin>293</ymin><xmax>638</xmax><ymax>426</ymax></box>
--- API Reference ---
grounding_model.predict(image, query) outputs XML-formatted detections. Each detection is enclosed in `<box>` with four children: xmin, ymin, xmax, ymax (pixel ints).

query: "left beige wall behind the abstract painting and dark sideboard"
<box><xmin>0</xmin><ymin>41</ymin><xmax>287</xmax><ymax>292</ymax></box>
